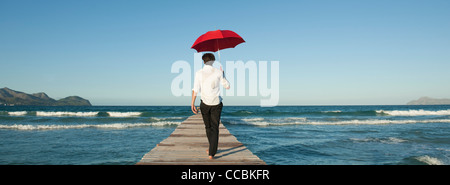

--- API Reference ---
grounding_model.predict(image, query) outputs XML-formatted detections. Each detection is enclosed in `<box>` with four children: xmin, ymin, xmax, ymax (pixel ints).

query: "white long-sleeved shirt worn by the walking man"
<box><xmin>192</xmin><ymin>64</ymin><xmax>230</xmax><ymax>106</ymax></box>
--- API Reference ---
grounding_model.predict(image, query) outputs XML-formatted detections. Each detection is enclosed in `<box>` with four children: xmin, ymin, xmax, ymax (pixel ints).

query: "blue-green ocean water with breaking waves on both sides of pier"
<box><xmin>0</xmin><ymin>103</ymin><xmax>450</xmax><ymax>165</ymax></box>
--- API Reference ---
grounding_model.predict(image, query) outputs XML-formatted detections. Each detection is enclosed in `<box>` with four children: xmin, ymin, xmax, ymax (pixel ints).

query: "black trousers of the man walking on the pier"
<box><xmin>200</xmin><ymin>101</ymin><xmax>223</xmax><ymax>156</ymax></box>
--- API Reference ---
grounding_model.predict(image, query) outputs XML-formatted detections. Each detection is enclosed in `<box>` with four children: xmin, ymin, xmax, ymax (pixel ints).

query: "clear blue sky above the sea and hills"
<box><xmin>0</xmin><ymin>0</ymin><xmax>450</xmax><ymax>105</ymax></box>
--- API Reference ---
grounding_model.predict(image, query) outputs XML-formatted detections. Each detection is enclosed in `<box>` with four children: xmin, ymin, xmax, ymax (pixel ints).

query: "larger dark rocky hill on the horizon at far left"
<box><xmin>0</xmin><ymin>87</ymin><xmax>92</xmax><ymax>106</ymax></box>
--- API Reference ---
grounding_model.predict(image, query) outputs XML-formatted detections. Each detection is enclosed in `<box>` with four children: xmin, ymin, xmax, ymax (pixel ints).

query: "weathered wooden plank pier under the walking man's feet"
<box><xmin>137</xmin><ymin>114</ymin><xmax>266</xmax><ymax>165</ymax></box>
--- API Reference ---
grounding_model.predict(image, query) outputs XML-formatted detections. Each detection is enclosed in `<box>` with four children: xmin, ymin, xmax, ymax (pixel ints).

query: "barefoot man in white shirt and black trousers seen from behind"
<box><xmin>191</xmin><ymin>53</ymin><xmax>230</xmax><ymax>159</ymax></box>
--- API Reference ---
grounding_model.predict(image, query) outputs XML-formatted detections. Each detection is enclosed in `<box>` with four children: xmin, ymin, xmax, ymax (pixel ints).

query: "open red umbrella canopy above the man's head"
<box><xmin>191</xmin><ymin>30</ymin><xmax>245</xmax><ymax>52</ymax></box>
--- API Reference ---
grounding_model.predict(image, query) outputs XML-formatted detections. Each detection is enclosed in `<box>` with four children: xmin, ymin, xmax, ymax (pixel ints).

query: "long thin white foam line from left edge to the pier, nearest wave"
<box><xmin>0</xmin><ymin>121</ymin><xmax>181</xmax><ymax>130</ymax></box>
